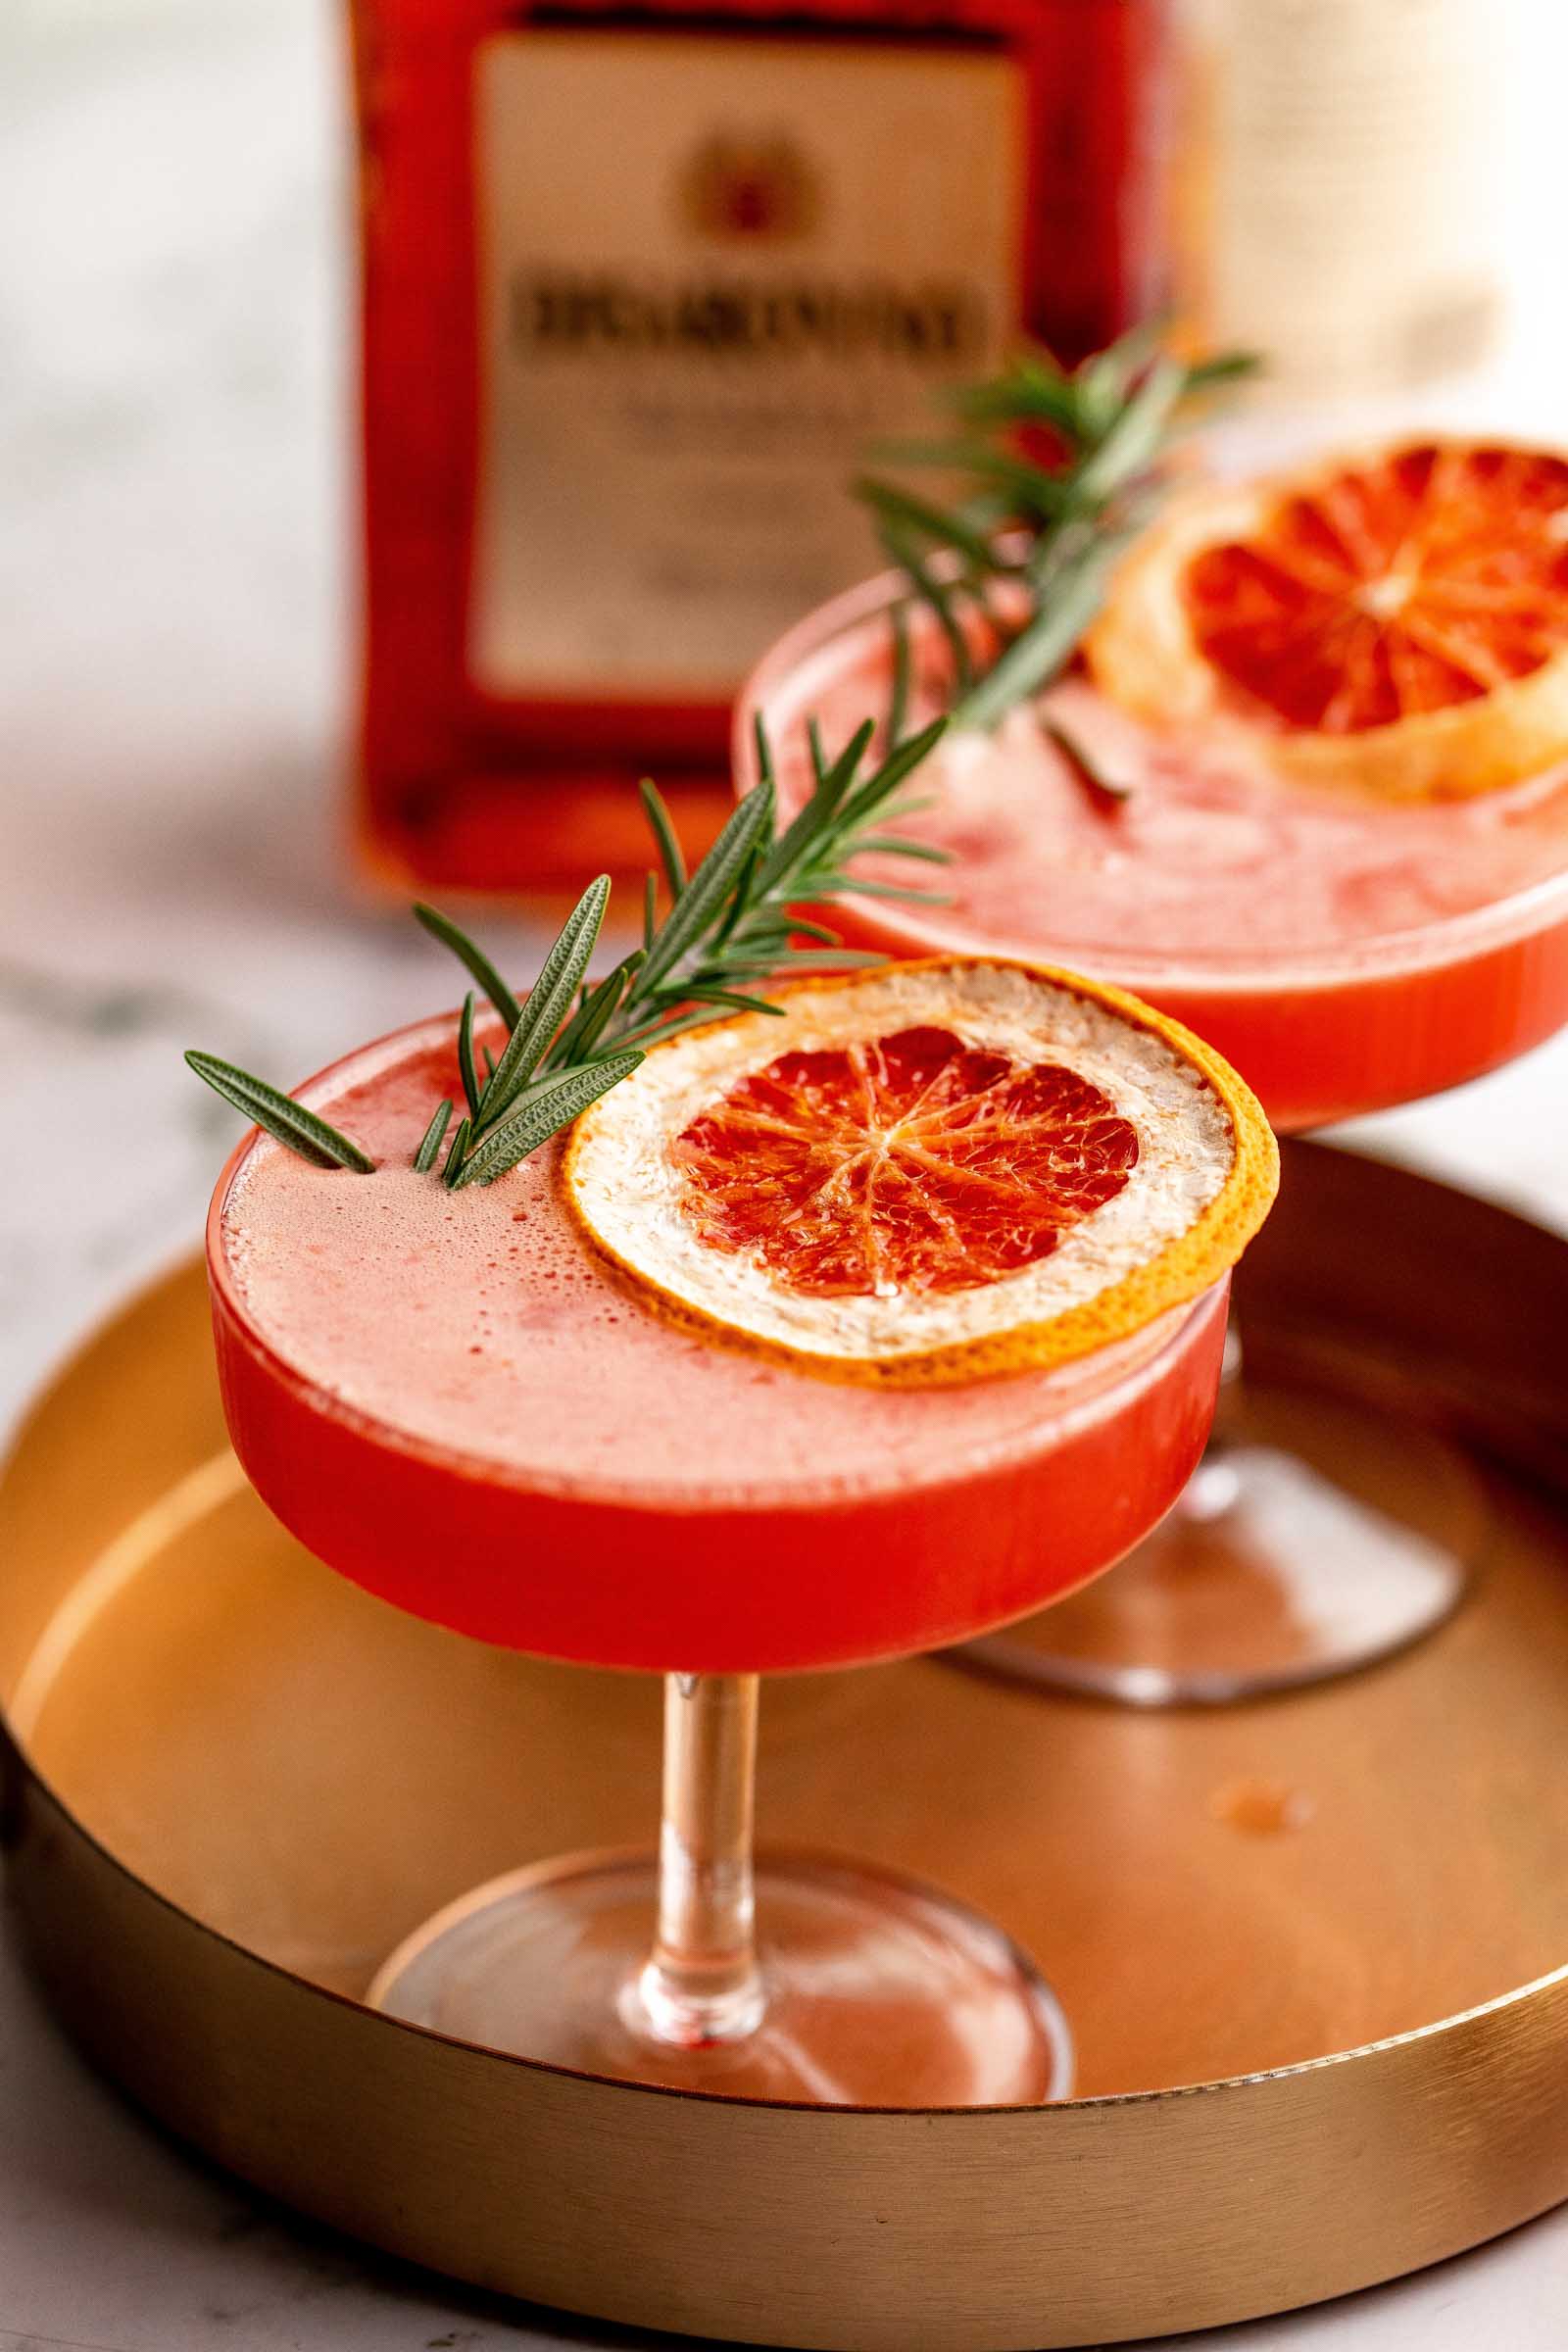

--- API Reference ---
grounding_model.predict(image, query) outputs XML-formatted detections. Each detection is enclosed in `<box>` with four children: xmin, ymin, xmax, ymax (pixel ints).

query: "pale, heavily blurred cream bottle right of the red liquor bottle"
<box><xmin>1178</xmin><ymin>0</ymin><xmax>1511</xmax><ymax>400</ymax></box>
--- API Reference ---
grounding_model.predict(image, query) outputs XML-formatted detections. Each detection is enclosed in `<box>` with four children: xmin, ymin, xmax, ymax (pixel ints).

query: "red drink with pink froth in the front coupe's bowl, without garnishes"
<box><xmin>207</xmin><ymin>1018</ymin><xmax>1225</xmax><ymax>1672</ymax></box>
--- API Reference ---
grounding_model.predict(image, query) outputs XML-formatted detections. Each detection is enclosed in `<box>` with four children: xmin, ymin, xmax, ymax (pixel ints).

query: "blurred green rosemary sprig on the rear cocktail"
<box><xmin>856</xmin><ymin>327</ymin><xmax>1257</xmax><ymax>741</ymax></box>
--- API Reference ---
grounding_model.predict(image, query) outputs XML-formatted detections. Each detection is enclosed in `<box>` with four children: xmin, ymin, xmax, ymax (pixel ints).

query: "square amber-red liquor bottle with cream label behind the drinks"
<box><xmin>353</xmin><ymin>0</ymin><xmax>1168</xmax><ymax>892</ymax></box>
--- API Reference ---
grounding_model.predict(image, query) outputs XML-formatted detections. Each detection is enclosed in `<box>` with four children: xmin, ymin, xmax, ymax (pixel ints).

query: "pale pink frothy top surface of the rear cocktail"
<box><xmin>768</xmin><ymin>618</ymin><xmax>1568</xmax><ymax>978</ymax></box>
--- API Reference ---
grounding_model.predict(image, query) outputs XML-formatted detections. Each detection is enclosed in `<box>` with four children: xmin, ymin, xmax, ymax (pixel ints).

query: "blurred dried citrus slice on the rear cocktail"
<box><xmin>1086</xmin><ymin>440</ymin><xmax>1568</xmax><ymax>800</ymax></box>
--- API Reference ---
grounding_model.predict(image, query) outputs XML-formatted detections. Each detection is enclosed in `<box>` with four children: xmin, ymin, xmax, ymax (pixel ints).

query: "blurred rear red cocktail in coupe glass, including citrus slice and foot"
<box><xmin>736</xmin><ymin>445</ymin><xmax>1568</xmax><ymax>1703</ymax></box>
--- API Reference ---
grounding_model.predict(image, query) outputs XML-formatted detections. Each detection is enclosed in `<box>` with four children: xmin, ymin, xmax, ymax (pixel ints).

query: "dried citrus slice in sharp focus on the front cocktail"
<box><xmin>562</xmin><ymin>957</ymin><xmax>1277</xmax><ymax>1386</ymax></box>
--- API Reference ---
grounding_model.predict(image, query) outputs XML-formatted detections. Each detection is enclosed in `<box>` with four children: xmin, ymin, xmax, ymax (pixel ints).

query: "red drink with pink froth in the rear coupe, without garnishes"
<box><xmin>736</xmin><ymin>564</ymin><xmax>1568</xmax><ymax>1134</ymax></box>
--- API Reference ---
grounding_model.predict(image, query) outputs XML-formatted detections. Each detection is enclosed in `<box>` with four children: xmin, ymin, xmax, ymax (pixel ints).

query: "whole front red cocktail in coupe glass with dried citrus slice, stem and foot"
<box><xmin>209</xmin><ymin>964</ymin><xmax>1272</xmax><ymax>2105</ymax></box>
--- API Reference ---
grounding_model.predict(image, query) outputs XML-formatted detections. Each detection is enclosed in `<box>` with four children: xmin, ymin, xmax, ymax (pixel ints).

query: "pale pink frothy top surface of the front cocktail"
<box><xmin>223</xmin><ymin>1018</ymin><xmax>1180</xmax><ymax>1507</ymax></box>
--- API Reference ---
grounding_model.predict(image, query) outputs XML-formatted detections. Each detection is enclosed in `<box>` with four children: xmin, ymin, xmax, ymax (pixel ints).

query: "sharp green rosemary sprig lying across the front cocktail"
<box><xmin>186</xmin><ymin>719</ymin><xmax>948</xmax><ymax>1190</ymax></box>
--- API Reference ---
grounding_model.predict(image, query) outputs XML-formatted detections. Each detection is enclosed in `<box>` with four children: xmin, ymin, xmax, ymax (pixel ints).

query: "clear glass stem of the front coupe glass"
<box><xmin>637</xmin><ymin>1675</ymin><xmax>764</xmax><ymax>2048</ymax></box>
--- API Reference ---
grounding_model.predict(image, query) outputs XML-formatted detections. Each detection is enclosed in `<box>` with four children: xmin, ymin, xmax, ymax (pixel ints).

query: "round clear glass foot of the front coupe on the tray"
<box><xmin>369</xmin><ymin>1853</ymin><xmax>1072</xmax><ymax>2107</ymax></box>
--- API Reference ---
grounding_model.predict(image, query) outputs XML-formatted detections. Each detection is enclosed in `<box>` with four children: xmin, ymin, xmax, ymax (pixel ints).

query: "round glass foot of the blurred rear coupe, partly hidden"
<box><xmin>950</xmin><ymin>1378</ymin><xmax>1484</xmax><ymax>1707</ymax></box>
